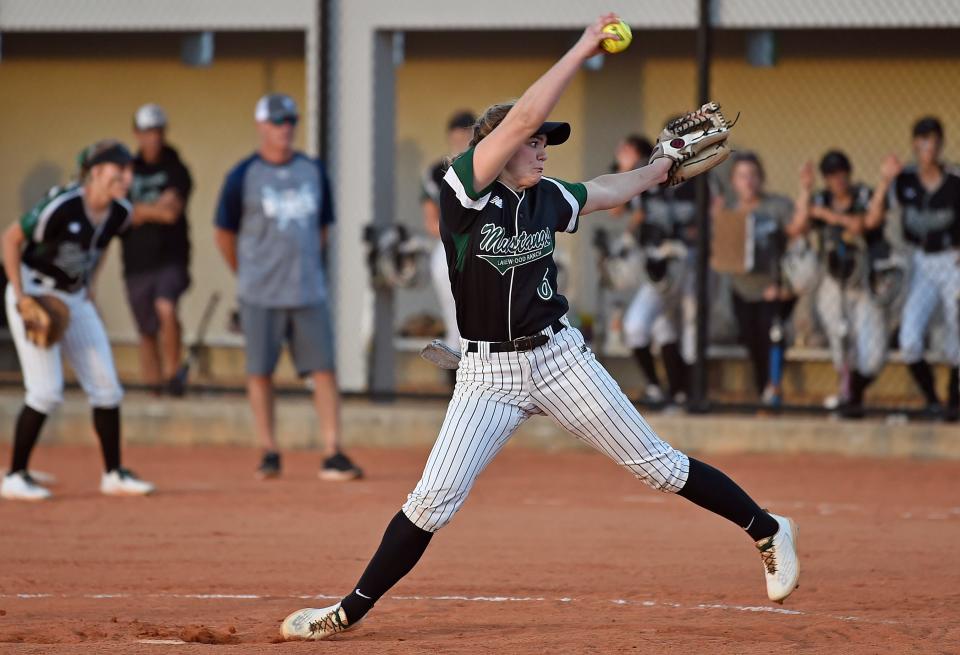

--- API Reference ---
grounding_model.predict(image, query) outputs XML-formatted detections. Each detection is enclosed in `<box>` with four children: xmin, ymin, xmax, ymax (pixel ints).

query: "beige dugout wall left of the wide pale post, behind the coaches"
<box><xmin>0</xmin><ymin>33</ymin><xmax>305</xmax><ymax>340</ymax></box>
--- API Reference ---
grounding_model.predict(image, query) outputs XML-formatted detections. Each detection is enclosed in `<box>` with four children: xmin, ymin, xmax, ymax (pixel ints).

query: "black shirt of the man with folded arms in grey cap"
<box><xmin>121</xmin><ymin>146</ymin><xmax>193</xmax><ymax>275</ymax></box>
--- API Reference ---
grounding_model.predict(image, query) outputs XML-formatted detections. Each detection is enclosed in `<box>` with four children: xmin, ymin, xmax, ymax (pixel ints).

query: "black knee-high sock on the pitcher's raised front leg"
<box><xmin>678</xmin><ymin>457</ymin><xmax>778</xmax><ymax>541</ymax></box>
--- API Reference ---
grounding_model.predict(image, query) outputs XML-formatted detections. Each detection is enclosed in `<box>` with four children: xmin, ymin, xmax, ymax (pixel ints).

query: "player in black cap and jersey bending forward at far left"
<box><xmin>0</xmin><ymin>140</ymin><xmax>154</xmax><ymax>500</ymax></box>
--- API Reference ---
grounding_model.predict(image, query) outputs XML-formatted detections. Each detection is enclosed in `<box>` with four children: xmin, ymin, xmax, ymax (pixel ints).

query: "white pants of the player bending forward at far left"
<box><xmin>5</xmin><ymin>274</ymin><xmax>123</xmax><ymax>414</ymax></box>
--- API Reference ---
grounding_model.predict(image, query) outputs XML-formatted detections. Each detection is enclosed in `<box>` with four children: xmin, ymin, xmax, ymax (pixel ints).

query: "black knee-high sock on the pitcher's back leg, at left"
<box><xmin>340</xmin><ymin>511</ymin><xmax>433</xmax><ymax>623</ymax></box>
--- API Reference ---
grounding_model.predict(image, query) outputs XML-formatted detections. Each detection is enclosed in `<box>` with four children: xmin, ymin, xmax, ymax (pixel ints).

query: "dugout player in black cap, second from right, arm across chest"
<box><xmin>793</xmin><ymin>150</ymin><xmax>887</xmax><ymax>418</ymax></box>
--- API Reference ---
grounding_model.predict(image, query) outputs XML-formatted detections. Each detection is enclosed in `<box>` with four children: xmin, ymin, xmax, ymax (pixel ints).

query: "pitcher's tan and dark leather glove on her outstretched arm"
<box><xmin>650</xmin><ymin>102</ymin><xmax>733</xmax><ymax>186</ymax></box>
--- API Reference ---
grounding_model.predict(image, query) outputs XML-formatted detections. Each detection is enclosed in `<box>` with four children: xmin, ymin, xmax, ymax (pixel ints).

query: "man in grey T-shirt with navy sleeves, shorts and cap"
<box><xmin>214</xmin><ymin>93</ymin><xmax>362</xmax><ymax>480</ymax></box>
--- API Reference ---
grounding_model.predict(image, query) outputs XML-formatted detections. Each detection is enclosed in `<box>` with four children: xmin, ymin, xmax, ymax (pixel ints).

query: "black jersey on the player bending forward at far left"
<box><xmin>20</xmin><ymin>186</ymin><xmax>131</xmax><ymax>293</ymax></box>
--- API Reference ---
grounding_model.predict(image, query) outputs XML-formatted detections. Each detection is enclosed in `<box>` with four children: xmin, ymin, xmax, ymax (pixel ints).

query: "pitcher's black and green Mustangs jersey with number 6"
<box><xmin>440</xmin><ymin>148</ymin><xmax>587</xmax><ymax>341</ymax></box>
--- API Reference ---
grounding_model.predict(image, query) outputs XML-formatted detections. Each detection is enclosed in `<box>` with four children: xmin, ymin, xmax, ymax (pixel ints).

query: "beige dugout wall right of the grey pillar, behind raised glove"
<box><xmin>642</xmin><ymin>31</ymin><xmax>960</xmax><ymax>195</ymax></box>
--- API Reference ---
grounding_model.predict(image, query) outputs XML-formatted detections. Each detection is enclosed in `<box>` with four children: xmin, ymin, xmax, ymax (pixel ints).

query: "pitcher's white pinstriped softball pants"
<box><xmin>403</xmin><ymin>327</ymin><xmax>690</xmax><ymax>532</ymax></box>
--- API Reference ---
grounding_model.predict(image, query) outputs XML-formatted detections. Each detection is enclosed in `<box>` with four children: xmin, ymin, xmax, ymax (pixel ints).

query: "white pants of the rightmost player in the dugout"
<box><xmin>900</xmin><ymin>250</ymin><xmax>960</xmax><ymax>366</ymax></box>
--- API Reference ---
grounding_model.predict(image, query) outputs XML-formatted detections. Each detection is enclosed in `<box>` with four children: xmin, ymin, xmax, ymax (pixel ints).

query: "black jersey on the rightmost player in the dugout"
<box><xmin>887</xmin><ymin>167</ymin><xmax>960</xmax><ymax>252</ymax></box>
